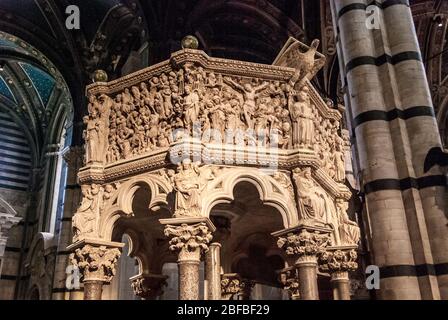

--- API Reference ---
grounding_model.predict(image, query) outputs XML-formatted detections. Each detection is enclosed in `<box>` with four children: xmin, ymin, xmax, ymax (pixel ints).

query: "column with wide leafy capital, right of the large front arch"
<box><xmin>272</xmin><ymin>224</ymin><xmax>331</xmax><ymax>300</ymax></box>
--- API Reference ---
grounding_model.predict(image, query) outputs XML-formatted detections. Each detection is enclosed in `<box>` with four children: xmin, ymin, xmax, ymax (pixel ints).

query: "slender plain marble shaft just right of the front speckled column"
<box><xmin>204</xmin><ymin>242</ymin><xmax>221</xmax><ymax>300</ymax></box>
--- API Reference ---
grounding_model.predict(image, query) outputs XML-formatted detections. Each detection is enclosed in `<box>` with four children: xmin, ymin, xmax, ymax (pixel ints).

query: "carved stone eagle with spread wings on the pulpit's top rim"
<box><xmin>274</xmin><ymin>38</ymin><xmax>326</xmax><ymax>88</ymax></box>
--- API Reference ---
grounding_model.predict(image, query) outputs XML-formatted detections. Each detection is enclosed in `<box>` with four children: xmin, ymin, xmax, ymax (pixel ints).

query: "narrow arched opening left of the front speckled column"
<box><xmin>107</xmin><ymin>183</ymin><xmax>173</xmax><ymax>300</ymax></box>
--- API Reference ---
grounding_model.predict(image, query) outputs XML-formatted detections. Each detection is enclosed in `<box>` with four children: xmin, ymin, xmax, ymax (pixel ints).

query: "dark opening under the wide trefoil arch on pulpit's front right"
<box><xmin>210</xmin><ymin>181</ymin><xmax>285</xmax><ymax>299</ymax></box>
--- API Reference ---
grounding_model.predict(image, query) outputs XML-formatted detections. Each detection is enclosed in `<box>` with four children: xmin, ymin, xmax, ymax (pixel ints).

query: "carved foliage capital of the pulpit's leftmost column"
<box><xmin>70</xmin><ymin>245</ymin><xmax>121</xmax><ymax>282</ymax></box>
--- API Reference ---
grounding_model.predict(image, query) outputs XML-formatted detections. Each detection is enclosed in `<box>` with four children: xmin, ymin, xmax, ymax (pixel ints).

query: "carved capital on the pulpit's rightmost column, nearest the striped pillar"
<box><xmin>319</xmin><ymin>246</ymin><xmax>358</xmax><ymax>272</ymax></box>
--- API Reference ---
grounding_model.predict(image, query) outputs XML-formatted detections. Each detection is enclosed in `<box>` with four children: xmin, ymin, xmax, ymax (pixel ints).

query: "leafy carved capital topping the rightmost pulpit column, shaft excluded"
<box><xmin>319</xmin><ymin>249</ymin><xmax>358</xmax><ymax>273</ymax></box>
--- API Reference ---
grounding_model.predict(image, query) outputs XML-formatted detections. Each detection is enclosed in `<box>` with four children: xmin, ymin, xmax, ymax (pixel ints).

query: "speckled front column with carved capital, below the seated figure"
<box><xmin>159</xmin><ymin>218</ymin><xmax>215</xmax><ymax>300</ymax></box>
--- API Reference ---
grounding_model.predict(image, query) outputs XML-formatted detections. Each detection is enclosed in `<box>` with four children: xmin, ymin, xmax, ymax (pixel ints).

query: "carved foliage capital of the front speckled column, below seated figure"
<box><xmin>164</xmin><ymin>222</ymin><xmax>213</xmax><ymax>261</ymax></box>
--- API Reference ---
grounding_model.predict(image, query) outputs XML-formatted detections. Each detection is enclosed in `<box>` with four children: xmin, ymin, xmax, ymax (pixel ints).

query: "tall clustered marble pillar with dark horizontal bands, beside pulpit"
<box><xmin>331</xmin><ymin>0</ymin><xmax>448</xmax><ymax>299</ymax></box>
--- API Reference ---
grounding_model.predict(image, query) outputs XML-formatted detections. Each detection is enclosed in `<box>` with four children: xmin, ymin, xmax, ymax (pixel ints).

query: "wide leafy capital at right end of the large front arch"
<box><xmin>272</xmin><ymin>224</ymin><xmax>331</xmax><ymax>264</ymax></box>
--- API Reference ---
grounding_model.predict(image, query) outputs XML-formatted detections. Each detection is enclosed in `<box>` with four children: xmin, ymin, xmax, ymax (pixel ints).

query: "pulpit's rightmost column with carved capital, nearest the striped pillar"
<box><xmin>319</xmin><ymin>246</ymin><xmax>358</xmax><ymax>300</ymax></box>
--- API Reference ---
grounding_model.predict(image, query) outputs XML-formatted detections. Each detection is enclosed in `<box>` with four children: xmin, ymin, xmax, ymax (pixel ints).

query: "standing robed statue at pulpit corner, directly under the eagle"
<box><xmin>288</xmin><ymin>86</ymin><xmax>314</xmax><ymax>148</ymax></box>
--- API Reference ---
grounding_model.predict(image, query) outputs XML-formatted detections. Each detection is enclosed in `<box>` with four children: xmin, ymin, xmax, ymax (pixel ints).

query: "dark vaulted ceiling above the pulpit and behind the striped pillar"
<box><xmin>0</xmin><ymin>0</ymin><xmax>448</xmax><ymax>150</ymax></box>
